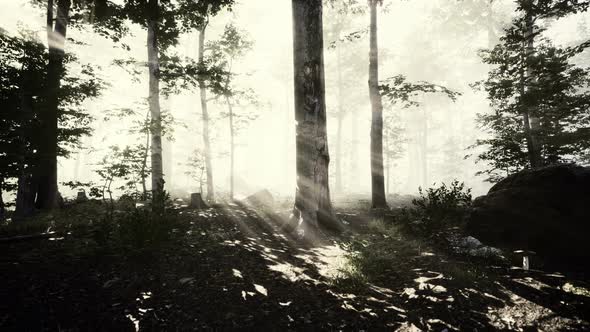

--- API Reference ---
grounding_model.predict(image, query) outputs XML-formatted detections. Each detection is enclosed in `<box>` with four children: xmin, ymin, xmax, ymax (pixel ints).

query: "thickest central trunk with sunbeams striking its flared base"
<box><xmin>292</xmin><ymin>0</ymin><xmax>340</xmax><ymax>237</ymax></box>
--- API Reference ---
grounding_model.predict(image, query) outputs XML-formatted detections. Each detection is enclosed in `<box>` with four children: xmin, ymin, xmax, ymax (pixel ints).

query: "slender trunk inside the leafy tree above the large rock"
<box><xmin>523</xmin><ymin>13</ymin><xmax>543</xmax><ymax>168</ymax></box>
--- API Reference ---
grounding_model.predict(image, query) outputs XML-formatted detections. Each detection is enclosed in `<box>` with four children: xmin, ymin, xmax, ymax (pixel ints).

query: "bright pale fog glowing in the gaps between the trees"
<box><xmin>0</xmin><ymin>0</ymin><xmax>590</xmax><ymax>197</ymax></box>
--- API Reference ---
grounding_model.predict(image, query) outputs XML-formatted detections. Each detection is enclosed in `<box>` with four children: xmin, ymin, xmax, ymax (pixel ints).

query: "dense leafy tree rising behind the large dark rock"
<box><xmin>476</xmin><ymin>0</ymin><xmax>590</xmax><ymax>181</ymax></box>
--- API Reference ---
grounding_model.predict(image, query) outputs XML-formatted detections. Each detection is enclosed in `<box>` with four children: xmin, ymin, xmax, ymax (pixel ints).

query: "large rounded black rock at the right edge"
<box><xmin>467</xmin><ymin>164</ymin><xmax>590</xmax><ymax>269</ymax></box>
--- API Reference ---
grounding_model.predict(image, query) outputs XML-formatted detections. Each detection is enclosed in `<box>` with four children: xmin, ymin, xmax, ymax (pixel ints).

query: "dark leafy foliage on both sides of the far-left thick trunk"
<box><xmin>0</xmin><ymin>32</ymin><xmax>102</xmax><ymax>219</ymax></box>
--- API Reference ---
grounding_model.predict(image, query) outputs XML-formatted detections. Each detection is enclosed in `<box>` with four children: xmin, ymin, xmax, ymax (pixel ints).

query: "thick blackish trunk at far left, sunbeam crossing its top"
<box><xmin>36</xmin><ymin>0</ymin><xmax>70</xmax><ymax>210</ymax></box>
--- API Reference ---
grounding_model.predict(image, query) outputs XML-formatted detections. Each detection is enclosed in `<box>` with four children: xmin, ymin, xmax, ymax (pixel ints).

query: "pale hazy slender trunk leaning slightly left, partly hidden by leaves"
<box><xmin>199</xmin><ymin>24</ymin><xmax>215</xmax><ymax>202</ymax></box>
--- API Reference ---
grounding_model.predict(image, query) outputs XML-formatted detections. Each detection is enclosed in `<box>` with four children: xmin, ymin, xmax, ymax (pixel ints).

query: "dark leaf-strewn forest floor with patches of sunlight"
<box><xmin>0</xmin><ymin>197</ymin><xmax>590</xmax><ymax>331</ymax></box>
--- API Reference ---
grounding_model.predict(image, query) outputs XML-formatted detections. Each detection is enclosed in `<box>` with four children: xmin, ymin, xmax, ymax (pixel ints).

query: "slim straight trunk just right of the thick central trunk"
<box><xmin>369</xmin><ymin>0</ymin><xmax>387</xmax><ymax>208</ymax></box>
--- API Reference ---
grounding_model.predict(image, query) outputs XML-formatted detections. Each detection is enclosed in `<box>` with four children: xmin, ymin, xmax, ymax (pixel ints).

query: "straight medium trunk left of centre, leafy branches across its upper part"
<box><xmin>147</xmin><ymin>0</ymin><xmax>164</xmax><ymax>199</ymax></box>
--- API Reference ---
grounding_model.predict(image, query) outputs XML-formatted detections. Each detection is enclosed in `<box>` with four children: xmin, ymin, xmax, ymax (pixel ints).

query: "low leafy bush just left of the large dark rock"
<box><xmin>398</xmin><ymin>180</ymin><xmax>472</xmax><ymax>236</ymax></box>
